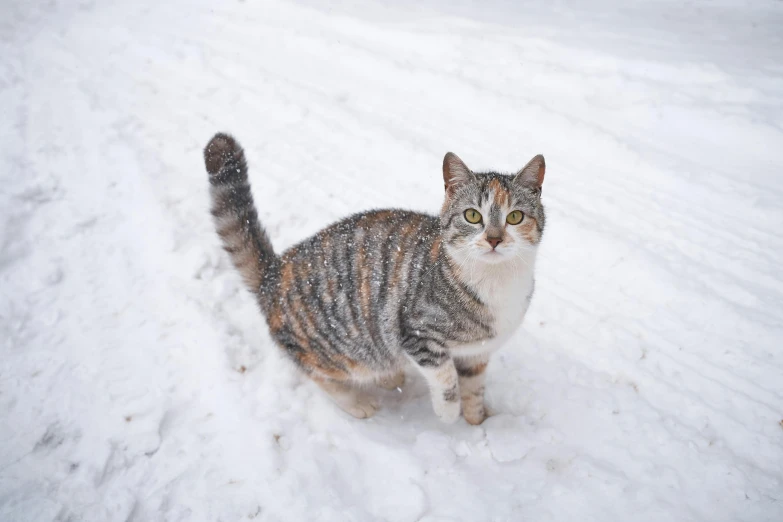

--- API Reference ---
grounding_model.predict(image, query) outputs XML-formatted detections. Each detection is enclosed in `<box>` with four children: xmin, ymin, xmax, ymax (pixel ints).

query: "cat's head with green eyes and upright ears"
<box><xmin>440</xmin><ymin>152</ymin><xmax>546</xmax><ymax>265</ymax></box>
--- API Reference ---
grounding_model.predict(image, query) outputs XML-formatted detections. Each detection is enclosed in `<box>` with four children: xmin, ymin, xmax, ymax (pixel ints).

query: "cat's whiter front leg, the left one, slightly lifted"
<box><xmin>405</xmin><ymin>341</ymin><xmax>460</xmax><ymax>423</ymax></box>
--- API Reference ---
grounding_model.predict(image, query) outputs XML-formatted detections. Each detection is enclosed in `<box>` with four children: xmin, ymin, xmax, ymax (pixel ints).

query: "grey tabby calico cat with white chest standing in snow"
<box><xmin>204</xmin><ymin>133</ymin><xmax>545</xmax><ymax>424</ymax></box>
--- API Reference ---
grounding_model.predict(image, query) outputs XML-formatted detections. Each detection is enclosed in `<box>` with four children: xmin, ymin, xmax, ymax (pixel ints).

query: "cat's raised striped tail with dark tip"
<box><xmin>204</xmin><ymin>133</ymin><xmax>277</xmax><ymax>294</ymax></box>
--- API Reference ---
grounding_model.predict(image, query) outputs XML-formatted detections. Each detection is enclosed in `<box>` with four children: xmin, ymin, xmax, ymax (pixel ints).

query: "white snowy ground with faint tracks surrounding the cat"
<box><xmin>0</xmin><ymin>0</ymin><xmax>783</xmax><ymax>522</ymax></box>
